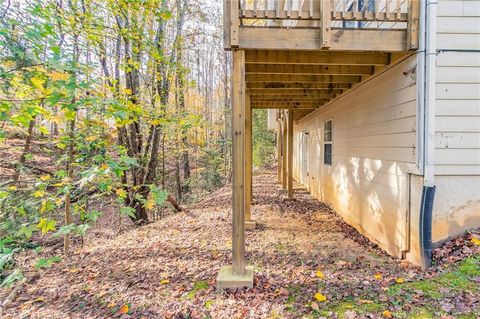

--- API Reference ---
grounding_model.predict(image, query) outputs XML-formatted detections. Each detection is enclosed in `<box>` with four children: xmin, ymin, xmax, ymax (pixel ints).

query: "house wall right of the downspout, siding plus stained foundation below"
<box><xmin>433</xmin><ymin>0</ymin><xmax>480</xmax><ymax>242</ymax></box>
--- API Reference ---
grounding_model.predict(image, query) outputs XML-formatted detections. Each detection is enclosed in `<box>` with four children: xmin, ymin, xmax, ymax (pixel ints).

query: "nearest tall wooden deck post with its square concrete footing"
<box><xmin>217</xmin><ymin>50</ymin><xmax>253</xmax><ymax>291</ymax></box>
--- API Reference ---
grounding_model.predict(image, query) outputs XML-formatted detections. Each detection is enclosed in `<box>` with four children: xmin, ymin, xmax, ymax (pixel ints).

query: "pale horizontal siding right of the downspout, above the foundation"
<box><xmin>435</xmin><ymin>0</ymin><xmax>480</xmax><ymax>175</ymax></box>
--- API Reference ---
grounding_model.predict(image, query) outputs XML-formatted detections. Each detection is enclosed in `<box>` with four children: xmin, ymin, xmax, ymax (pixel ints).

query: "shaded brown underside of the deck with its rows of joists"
<box><xmin>245</xmin><ymin>50</ymin><xmax>408</xmax><ymax>121</ymax></box>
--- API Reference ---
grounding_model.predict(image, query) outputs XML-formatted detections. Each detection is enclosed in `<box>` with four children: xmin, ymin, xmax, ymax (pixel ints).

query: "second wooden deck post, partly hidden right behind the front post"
<box><xmin>245</xmin><ymin>94</ymin><xmax>253</xmax><ymax>222</ymax></box>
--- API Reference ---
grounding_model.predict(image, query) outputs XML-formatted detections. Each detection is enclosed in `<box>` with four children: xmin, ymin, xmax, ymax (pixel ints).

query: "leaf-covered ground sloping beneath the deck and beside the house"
<box><xmin>0</xmin><ymin>172</ymin><xmax>480</xmax><ymax>319</ymax></box>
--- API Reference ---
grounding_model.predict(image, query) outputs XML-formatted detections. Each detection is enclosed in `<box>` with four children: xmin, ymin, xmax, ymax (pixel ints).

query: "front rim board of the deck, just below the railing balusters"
<box><xmin>240</xmin><ymin>27</ymin><xmax>407</xmax><ymax>52</ymax></box>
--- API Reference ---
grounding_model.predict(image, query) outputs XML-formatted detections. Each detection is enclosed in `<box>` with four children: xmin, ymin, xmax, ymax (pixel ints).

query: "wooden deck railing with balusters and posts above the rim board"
<box><xmin>225</xmin><ymin>0</ymin><xmax>419</xmax><ymax>49</ymax></box>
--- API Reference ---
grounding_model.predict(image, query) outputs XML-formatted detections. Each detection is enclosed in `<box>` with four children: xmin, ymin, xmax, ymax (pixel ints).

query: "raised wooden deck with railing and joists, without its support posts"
<box><xmin>224</xmin><ymin>0</ymin><xmax>419</xmax><ymax>120</ymax></box>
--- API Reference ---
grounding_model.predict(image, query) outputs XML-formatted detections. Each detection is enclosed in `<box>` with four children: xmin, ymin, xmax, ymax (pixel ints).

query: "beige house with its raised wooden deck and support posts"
<box><xmin>217</xmin><ymin>0</ymin><xmax>480</xmax><ymax>289</ymax></box>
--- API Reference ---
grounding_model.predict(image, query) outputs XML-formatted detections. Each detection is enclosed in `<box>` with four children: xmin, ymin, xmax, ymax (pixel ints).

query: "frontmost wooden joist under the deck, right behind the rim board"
<box><xmin>245</xmin><ymin>50</ymin><xmax>390</xmax><ymax>66</ymax></box>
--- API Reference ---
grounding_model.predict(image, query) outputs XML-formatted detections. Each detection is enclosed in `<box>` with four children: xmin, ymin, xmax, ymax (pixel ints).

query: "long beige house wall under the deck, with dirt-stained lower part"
<box><xmin>294</xmin><ymin>55</ymin><xmax>419</xmax><ymax>257</ymax></box>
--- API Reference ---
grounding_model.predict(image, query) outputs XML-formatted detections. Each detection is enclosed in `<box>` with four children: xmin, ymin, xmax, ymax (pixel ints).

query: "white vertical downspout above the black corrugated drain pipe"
<box><xmin>423</xmin><ymin>0</ymin><xmax>438</xmax><ymax>187</ymax></box>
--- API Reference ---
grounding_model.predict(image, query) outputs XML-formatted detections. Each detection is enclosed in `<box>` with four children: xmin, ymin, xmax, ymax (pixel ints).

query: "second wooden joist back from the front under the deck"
<box><xmin>246</xmin><ymin>64</ymin><xmax>374</xmax><ymax>75</ymax></box>
